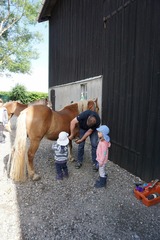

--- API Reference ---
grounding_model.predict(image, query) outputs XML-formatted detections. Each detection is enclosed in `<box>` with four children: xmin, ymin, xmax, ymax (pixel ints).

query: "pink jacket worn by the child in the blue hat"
<box><xmin>96</xmin><ymin>140</ymin><xmax>111</xmax><ymax>166</ymax></box>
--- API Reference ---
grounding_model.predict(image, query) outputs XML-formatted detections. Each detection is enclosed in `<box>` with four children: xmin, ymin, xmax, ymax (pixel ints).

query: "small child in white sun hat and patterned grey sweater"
<box><xmin>52</xmin><ymin>132</ymin><xmax>69</xmax><ymax>180</ymax></box>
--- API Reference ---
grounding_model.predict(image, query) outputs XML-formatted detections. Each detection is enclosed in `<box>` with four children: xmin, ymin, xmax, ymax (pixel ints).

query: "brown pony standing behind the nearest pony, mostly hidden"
<box><xmin>4</xmin><ymin>98</ymin><xmax>52</xmax><ymax>132</ymax></box>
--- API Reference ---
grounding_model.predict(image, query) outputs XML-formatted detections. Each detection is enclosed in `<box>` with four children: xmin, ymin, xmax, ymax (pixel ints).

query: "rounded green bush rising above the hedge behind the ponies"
<box><xmin>10</xmin><ymin>84</ymin><xmax>27</xmax><ymax>103</ymax></box>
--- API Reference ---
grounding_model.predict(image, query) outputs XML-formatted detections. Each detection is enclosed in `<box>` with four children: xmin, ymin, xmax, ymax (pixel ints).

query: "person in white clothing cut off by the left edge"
<box><xmin>0</xmin><ymin>99</ymin><xmax>8</xmax><ymax>143</ymax></box>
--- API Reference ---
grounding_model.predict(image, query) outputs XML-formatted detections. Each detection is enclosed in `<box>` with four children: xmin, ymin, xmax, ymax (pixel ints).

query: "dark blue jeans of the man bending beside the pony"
<box><xmin>77</xmin><ymin>129</ymin><xmax>98</xmax><ymax>164</ymax></box>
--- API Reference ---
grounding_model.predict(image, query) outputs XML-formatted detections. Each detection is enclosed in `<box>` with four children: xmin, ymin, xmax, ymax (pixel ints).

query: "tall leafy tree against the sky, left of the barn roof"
<box><xmin>0</xmin><ymin>0</ymin><xmax>42</xmax><ymax>73</ymax></box>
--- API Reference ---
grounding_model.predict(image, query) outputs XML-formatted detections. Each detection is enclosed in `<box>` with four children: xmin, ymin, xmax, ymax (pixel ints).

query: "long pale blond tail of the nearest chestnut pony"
<box><xmin>10</xmin><ymin>110</ymin><xmax>27</xmax><ymax>182</ymax></box>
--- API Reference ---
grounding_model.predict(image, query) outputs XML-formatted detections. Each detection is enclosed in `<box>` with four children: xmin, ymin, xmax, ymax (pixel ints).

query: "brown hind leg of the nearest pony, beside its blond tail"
<box><xmin>27</xmin><ymin>141</ymin><xmax>41</xmax><ymax>181</ymax></box>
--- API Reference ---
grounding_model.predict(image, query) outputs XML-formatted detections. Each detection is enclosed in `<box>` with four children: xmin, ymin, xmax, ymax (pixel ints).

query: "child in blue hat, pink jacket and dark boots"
<box><xmin>94</xmin><ymin>125</ymin><xmax>111</xmax><ymax>188</ymax></box>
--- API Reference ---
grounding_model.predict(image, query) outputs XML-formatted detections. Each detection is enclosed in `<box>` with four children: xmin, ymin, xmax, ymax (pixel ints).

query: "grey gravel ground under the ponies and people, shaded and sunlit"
<box><xmin>0</xmin><ymin>118</ymin><xmax>160</xmax><ymax>240</ymax></box>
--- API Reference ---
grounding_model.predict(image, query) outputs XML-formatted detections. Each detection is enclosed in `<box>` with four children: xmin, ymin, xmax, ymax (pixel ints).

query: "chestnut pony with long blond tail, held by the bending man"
<box><xmin>10</xmin><ymin>99</ymin><xmax>99</xmax><ymax>181</ymax></box>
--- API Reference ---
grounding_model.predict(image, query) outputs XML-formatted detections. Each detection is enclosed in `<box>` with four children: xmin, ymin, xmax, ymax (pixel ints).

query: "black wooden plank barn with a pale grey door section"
<box><xmin>38</xmin><ymin>0</ymin><xmax>160</xmax><ymax>181</ymax></box>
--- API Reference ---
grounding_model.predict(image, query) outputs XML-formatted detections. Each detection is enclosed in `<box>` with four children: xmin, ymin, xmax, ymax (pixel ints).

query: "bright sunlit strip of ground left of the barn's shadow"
<box><xmin>0</xmin><ymin>125</ymin><xmax>21</xmax><ymax>240</ymax></box>
